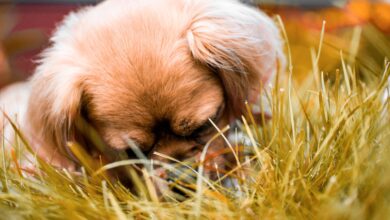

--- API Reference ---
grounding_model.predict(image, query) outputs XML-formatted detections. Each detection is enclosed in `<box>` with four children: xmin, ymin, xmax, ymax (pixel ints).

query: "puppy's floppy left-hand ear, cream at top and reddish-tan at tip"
<box><xmin>27</xmin><ymin>57</ymin><xmax>83</xmax><ymax>165</ymax></box>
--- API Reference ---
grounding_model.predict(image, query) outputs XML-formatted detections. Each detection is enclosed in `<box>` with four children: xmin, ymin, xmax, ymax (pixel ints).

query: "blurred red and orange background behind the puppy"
<box><xmin>0</xmin><ymin>0</ymin><xmax>390</xmax><ymax>88</ymax></box>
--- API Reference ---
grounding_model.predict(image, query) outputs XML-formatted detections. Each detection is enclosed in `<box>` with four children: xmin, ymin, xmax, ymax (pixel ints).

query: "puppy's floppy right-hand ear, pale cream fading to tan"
<box><xmin>186</xmin><ymin>0</ymin><xmax>284</xmax><ymax>116</ymax></box>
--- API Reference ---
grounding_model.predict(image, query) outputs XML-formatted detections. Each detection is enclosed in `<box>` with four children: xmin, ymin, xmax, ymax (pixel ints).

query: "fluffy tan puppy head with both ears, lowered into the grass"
<box><xmin>3</xmin><ymin>0</ymin><xmax>284</xmax><ymax>181</ymax></box>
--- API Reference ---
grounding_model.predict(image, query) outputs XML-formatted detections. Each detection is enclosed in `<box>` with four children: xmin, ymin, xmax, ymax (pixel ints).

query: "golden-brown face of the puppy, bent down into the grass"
<box><xmin>83</xmin><ymin>51</ymin><xmax>228</xmax><ymax>162</ymax></box>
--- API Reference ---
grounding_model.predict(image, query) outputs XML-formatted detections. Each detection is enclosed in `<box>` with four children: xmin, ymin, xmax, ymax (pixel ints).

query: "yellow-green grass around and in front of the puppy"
<box><xmin>0</xmin><ymin>21</ymin><xmax>390</xmax><ymax>219</ymax></box>
